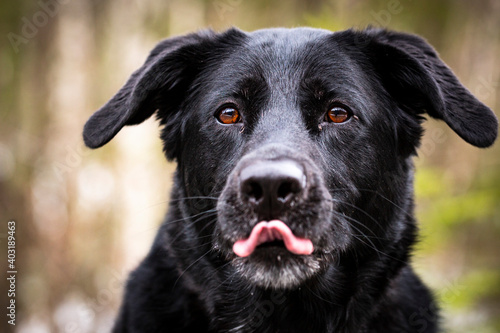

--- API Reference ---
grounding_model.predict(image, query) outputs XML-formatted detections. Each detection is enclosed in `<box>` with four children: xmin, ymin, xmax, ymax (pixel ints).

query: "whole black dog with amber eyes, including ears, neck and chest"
<box><xmin>84</xmin><ymin>28</ymin><xmax>497</xmax><ymax>333</ymax></box>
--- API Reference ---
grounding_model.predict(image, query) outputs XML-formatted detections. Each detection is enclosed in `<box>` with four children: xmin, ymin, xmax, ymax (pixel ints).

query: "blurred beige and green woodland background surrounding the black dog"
<box><xmin>0</xmin><ymin>0</ymin><xmax>500</xmax><ymax>333</ymax></box>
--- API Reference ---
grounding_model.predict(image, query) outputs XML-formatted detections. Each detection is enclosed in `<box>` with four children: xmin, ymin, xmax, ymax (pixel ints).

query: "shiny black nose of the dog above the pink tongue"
<box><xmin>240</xmin><ymin>159</ymin><xmax>306</xmax><ymax>220</ymax></box>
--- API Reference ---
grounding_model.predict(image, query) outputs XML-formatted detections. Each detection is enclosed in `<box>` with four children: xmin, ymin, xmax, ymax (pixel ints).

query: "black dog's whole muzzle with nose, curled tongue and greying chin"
<box><xmin>214</xmin><ymin>146</ymin><xmax>345</xmax><ymax>289</ymax></box>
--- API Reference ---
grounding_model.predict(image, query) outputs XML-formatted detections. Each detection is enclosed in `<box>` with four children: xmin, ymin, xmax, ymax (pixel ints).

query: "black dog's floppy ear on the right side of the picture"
<box><xmin>364</xmin><ymin>29</ymin><xmax>498</xmax><ymax>147</ymax></box>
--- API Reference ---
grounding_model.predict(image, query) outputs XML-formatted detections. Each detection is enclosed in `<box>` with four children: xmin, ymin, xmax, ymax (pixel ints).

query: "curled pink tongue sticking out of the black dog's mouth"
<box><xmin>233</xmin><ymin>220</ymin><xmax>314</xmax><ymax>257</ymax></box>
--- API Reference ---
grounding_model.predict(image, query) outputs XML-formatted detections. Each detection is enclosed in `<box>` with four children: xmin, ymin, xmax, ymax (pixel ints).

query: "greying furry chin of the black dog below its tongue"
<box><xmin>232</xmin><ymin>248</ymin><xmax>325</xmax><ymax>290</ymax></box>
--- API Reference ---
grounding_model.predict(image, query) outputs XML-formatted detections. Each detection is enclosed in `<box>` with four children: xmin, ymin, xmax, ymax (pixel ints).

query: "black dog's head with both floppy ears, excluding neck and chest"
<box><xmin>84</xmin><ymin>29</ymin><xmax>497</xmax><ymax>289</ymax></box>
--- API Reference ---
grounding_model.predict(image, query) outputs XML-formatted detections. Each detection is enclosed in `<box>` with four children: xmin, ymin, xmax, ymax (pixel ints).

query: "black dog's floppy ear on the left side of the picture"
<box><xmin>83</xmin><ymin>29</ymin><xmax>243</xmax><ymax>148</ymax></box>
